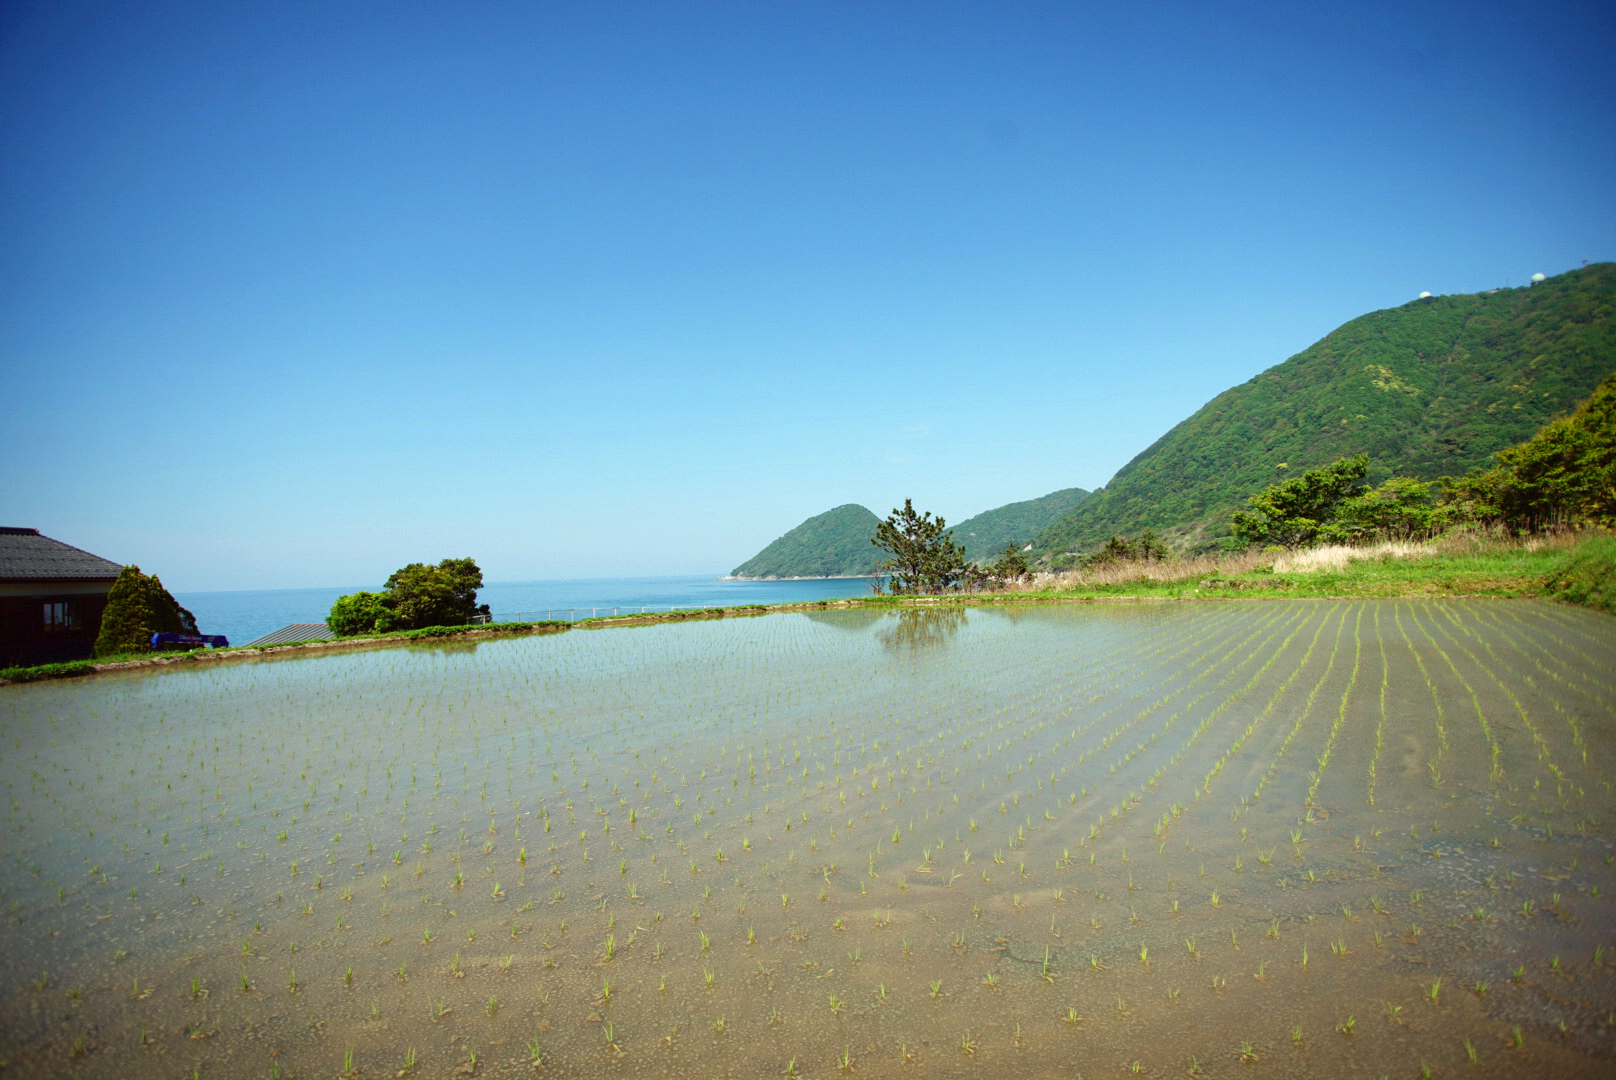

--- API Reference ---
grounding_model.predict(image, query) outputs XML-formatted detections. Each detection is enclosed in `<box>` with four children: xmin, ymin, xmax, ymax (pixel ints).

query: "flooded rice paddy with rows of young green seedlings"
<box><xmin>0</xmin><ymin>601</ymin><xmax>1616</xmax><ymax>1078</ymax></box>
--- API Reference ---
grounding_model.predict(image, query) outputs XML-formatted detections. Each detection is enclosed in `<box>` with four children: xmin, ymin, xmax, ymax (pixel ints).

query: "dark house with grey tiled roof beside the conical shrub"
<box><xmin>0</xmin><ymin>525</ymin><xmax>123</xmax><ymax>666</ymax></box>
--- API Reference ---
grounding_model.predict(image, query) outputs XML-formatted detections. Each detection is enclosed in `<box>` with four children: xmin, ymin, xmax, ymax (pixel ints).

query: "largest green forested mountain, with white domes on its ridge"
<box><xmin>1033</xmin><ymin>262</ymin><xmax>1616</xmax><ymax>556</ymax></box>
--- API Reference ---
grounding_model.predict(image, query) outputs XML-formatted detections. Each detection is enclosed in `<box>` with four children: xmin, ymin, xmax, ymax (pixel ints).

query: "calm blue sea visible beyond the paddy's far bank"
<box><xmin>175</xmin><ymin>576</ymin><xmax>869</xmax><ymax>645</ymax></box>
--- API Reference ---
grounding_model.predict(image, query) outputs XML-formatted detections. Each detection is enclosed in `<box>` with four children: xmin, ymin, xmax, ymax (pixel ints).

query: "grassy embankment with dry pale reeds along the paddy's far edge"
<box><xmin>0</xmin><ymin>532</ymin><xmax>1616</xmax><ymax>682</ymax></box>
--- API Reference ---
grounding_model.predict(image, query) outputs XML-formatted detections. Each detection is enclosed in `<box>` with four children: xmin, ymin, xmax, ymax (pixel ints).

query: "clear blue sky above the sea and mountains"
<box><xmin>0</xmin><ymin>0</ymin><xmax>1616</xmax><ymax>590</ymax></box>
